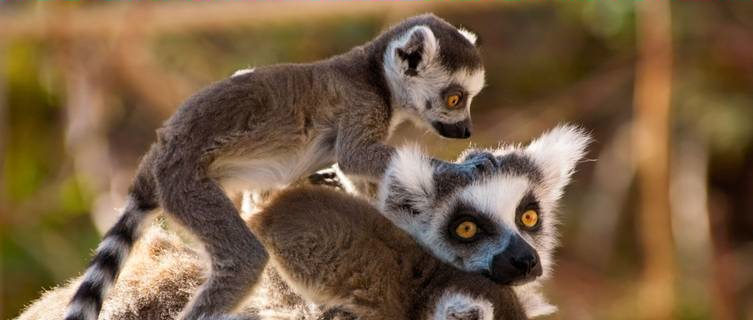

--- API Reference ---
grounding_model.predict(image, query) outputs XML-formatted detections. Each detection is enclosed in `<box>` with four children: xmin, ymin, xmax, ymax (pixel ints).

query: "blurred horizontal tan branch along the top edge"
<box><xmin>0</xmin><ymin>1</ymin><xmax>500</xmax><ymax>38</ymax></box>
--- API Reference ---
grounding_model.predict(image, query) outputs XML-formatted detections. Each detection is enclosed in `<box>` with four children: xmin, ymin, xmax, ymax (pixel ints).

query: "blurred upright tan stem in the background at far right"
<box><xmin>633</xmin><ymin>1</ymin><xmax>676</xmax><ymax>319</ymax></box>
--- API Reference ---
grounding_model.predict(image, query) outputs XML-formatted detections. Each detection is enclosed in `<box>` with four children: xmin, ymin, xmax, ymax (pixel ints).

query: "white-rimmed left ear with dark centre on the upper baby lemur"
<box><xmin>393</xmin><ymin>26</ymin><xmax>439</xmax><ymax>76</ymax></box>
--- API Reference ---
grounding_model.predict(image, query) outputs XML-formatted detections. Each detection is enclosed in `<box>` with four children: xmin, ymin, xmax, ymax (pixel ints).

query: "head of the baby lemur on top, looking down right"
<box><xmin>382</xmin><ymin>14</ymin><xmax>484</xmax><ymax>138</ymax></box>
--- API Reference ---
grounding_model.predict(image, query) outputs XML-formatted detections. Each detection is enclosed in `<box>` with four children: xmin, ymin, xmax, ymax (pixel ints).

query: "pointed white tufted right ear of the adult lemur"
<box><xmin>525</xmin><ymin>125</ymin><xmax>591</xmax><ymax>199</ymax></box>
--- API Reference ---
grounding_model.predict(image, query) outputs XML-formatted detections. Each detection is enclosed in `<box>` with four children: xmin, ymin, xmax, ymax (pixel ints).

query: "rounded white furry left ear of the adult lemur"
<box><xmin>378</xmin><ymin>145</ymin><xmax>434</xmax><ymax>220</ymax></box>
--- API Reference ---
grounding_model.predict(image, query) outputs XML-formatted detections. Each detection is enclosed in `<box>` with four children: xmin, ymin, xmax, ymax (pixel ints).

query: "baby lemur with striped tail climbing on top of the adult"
<box><xmin>66</xmin><ymin>14</ymin><xmax>493</xmax><ymax>320</ymax></box>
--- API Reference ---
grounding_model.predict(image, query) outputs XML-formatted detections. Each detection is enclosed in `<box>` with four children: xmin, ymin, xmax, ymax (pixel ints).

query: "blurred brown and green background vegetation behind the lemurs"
<box><xmin>0</xmin><ymin>1</ymin><xmax>753</xmax><ymax>319</ymax></box>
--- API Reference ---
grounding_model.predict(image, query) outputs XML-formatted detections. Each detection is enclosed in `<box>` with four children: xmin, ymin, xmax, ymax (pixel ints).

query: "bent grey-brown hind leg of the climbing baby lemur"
<box><xmin>154</xmin><ymin>156</ymin><xmax>268</xmax><ymax>320</ymax></box>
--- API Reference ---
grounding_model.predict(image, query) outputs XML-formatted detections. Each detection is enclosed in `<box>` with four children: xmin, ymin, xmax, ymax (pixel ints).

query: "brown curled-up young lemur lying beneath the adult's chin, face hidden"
<box><xmin>249</xmin><ymin>187</ymin><xmax>525</xmax><ymax>320</ymax></box>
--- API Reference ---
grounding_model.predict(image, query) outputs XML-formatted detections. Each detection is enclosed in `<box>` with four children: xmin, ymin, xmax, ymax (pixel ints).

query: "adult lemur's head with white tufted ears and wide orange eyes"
<box><xmin>379</xmin><ymin>126</ymin><xmax>589</xmax><ymax>285</ymax></box>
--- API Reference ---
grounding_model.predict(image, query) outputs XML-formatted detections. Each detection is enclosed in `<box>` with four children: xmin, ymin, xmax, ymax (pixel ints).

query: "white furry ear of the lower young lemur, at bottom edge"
<box><xmin>429</xmin><ymin>292</ymin><xmax>494</xmax><ymax>320</ymax></box>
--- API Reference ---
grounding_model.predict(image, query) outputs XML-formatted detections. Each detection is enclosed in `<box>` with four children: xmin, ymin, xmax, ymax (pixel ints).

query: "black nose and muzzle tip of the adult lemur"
<box><xmin>490</xmin><ymin>235</ymin><xmax>542</xmax><ymax>285</ymax></box>
